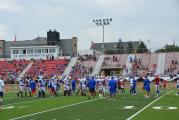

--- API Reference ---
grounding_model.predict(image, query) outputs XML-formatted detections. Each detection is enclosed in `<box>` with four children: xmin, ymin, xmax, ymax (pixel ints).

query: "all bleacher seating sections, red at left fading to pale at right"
<box><xmin>0</xmin><ymin>52</ymin><xmax>179</xmax><ymax>81</ymax></box>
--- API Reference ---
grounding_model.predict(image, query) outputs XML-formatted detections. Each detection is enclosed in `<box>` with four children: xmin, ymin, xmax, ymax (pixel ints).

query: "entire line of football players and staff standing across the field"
<box><xmin>0</xmin><ymin>74</ymin><xmax>179</xmax><ymax>112</ymax></box>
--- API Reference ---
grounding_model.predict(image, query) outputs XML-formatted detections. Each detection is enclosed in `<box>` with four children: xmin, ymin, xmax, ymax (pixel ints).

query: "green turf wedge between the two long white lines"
<box><xmin>19</xmin><ymin>94</ymin><xmax>155</xmax><ymax>120</ymax></box>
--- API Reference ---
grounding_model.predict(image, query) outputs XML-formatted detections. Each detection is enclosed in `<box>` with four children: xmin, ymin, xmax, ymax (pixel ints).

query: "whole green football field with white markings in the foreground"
<box><xmin>0</xmin><ymin>84</ymin><xmax>179</xmax><ymax>120</ymax></box>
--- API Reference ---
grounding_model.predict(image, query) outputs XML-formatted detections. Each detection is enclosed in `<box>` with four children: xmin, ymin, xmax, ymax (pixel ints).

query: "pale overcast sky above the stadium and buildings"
<box><xmin>0</xmin><ymin>0</ymin><xmax>179</xmax><ymax>50</ymax></box>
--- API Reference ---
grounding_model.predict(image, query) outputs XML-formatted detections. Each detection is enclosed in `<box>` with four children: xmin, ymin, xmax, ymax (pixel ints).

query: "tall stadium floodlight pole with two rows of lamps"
<box><xmin>93</xmin><ymin>18</ymin><xmax>112</xmax><ymax>53</ymax></box>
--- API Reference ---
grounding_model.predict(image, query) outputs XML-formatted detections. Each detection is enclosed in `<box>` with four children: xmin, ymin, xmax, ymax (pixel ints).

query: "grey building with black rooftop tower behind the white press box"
<box><xmin>0</xmin><ymin>30</ymin><xmax>77</xmax><ymax>59</ymax></box>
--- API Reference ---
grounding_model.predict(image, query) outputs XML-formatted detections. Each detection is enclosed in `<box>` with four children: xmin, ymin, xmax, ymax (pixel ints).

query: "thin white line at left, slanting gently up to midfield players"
<box><xmin>9</xmin><ymin>97</ymin><xmax>104</xmax><ymax>120</ymax></box>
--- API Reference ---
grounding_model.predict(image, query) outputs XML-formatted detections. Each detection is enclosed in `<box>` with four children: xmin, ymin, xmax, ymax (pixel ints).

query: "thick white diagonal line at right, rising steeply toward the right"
<box><xmin>126</xmin><ymin>90</ymin><xmax>173</xmax><ymax>120</ymax></box>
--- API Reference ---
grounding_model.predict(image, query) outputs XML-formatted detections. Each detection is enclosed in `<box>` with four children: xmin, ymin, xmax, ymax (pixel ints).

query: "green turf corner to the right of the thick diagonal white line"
<box><xmin>134</xmin><ymin>91</ymin><xmax>179</xmax><ymax>120</ymax></box>
